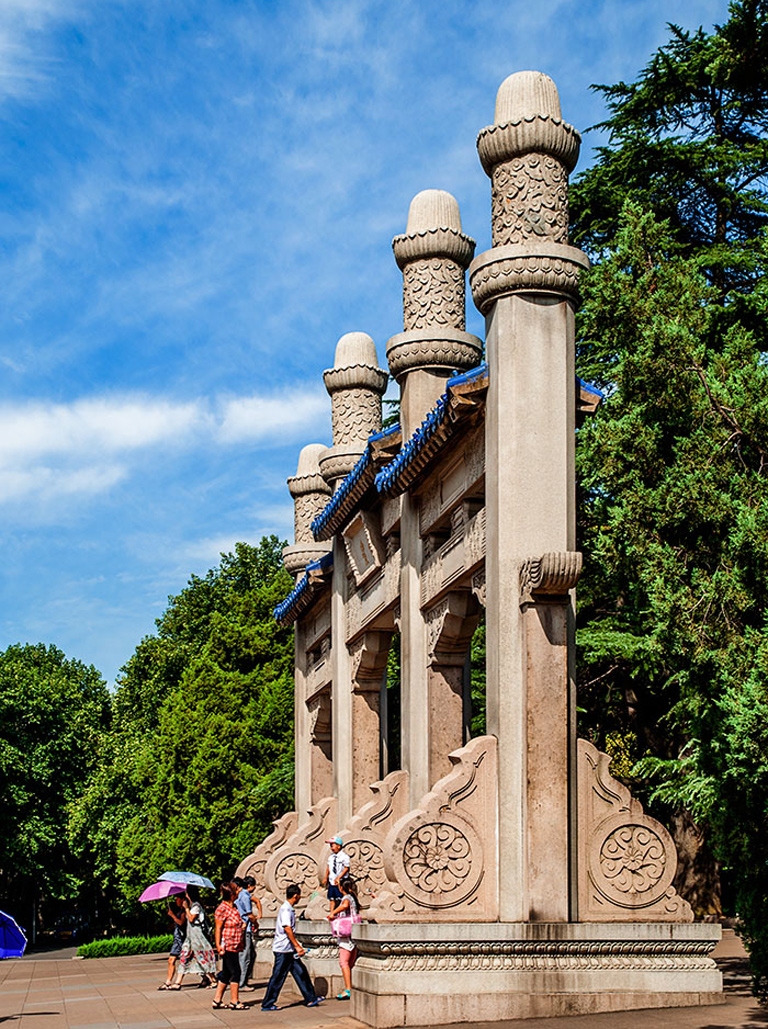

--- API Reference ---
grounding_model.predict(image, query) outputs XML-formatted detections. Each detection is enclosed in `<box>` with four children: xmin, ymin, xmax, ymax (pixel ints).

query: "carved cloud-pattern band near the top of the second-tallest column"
<box><xmin>403</xmin><ymin>257</ymin><xmax>464</xmax><ymax>331</ymax></box>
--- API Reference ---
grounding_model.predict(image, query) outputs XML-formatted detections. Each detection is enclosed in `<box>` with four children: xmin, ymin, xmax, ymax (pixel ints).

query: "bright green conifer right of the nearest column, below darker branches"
<box><xmin>578</xmin><ymin>205</ymin><xmax>768</xmax><ymax>988</ymax></box>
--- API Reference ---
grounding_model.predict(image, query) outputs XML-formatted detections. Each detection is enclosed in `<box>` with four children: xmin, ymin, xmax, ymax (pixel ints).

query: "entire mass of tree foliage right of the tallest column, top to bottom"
<box><xmin>572</xmin><ymin>0</ymin><xmax>768</xmax><ymax>996</ymax></box>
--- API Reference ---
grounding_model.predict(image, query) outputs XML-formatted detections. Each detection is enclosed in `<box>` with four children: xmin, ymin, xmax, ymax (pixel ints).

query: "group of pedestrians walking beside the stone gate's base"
<box><xmin>159</xmin><ymin>836</ymin><xmax>360</xmax><ymax>1012</ymax></box>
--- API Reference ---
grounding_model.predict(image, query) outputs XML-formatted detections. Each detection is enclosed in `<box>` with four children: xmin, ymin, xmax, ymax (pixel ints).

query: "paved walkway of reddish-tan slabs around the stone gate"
<box><xmin>0</xmin><ymin>933</ymin><xmax>768</xmax><ymax>1029</ymax></box>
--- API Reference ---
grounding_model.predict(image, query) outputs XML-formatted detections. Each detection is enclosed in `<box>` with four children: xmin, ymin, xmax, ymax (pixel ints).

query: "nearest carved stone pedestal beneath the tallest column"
<box><xmin>350</xmin><ymin>922</ymin><xmax>723</xmax><ymax>1029</ymax></box>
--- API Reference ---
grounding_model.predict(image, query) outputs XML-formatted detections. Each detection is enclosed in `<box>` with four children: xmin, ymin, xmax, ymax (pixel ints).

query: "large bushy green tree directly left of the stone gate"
<box><xmin>72</xmin><ymin>536</ymin><xmax>293</xmax><ymax>913</ymax></box>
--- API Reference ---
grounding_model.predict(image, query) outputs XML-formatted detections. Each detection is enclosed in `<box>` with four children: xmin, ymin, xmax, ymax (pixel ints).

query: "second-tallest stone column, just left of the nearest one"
<box><xmin>387</xmin><ymin>189</ymin><xmax>483</xmax><ymax>805</ymax></box>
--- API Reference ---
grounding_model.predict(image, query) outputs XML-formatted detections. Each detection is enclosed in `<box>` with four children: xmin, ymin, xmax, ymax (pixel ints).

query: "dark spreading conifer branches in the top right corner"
<box><xmin>571</xmin><ymin>0</ymin><xmax>768</xmax><ymax>306</ymax></box>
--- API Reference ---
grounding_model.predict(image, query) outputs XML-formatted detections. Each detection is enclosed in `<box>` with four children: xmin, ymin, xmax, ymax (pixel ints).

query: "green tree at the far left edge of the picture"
<box><xmin>0</xmin><ymin>643</ymin><xmax>109</xmax><ymax>928</ymax></box>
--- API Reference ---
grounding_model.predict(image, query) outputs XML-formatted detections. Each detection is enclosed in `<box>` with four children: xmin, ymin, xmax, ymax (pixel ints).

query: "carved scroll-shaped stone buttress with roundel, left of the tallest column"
<box><xmin>371</xmin><ymin>736</ymin><xmax>498</xmax><ymax>922</ymax></box>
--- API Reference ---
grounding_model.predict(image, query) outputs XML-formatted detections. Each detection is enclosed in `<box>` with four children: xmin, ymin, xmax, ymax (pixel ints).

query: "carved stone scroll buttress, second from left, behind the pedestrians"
<box><xmin>264</xmin><ymin>796</ymin><xmax>337</xmax><ymax>908</ymax></box>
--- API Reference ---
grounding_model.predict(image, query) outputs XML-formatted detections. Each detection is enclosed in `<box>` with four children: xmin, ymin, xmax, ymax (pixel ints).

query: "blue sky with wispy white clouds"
<box><xmin>0</xmin><ymin>0</ymin><xmax>727</xmax><ymax>681</ymax></box>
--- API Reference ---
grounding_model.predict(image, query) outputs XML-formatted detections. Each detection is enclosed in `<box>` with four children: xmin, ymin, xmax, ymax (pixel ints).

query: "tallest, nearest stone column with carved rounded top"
<box><xmin>469</xmin><ymin>72</ymin><xmax>588</xmax><ymax>922</ymax></box>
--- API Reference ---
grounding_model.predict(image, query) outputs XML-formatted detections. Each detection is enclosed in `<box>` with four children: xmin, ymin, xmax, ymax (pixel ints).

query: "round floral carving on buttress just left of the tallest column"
<box><xmin>403</xmin><ymin>822</ymin><xmax>472</xmax><ymax>894</ymax></box>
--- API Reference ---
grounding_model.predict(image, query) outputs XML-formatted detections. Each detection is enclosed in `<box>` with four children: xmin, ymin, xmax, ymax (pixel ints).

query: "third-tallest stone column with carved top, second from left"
<box><xmin>319</xmin><ymin>332</ymin><xmax>388</xmax><ymax>825</ymax></box>
